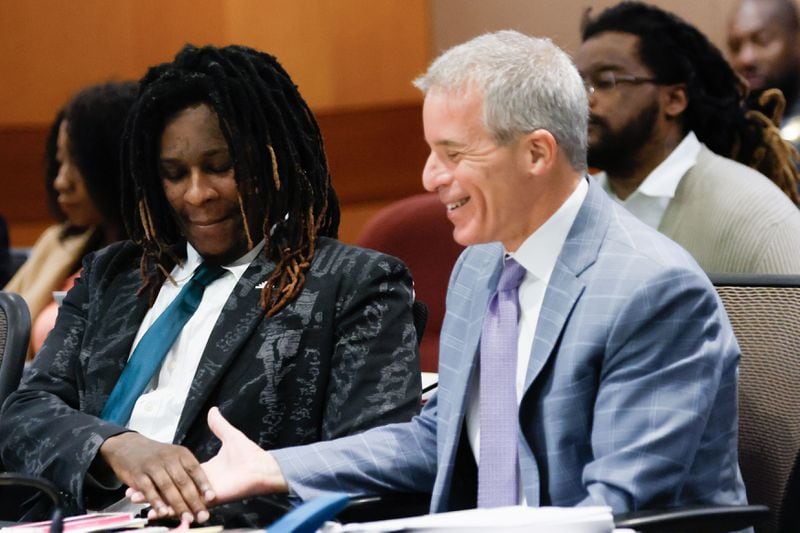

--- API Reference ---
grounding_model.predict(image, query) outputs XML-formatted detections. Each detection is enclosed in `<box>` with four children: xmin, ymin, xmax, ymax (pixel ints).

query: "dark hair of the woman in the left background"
<box><xmin>45</xmin><ymin>82</ymin><xmax>137</xmax><ymax>255</ymax></box>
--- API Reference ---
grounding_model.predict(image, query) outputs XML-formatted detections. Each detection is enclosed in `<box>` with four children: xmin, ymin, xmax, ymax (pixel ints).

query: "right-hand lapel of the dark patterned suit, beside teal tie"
<box><xmin>174</xmin><ymin>253</ymin><xmax>275</xmax><ymax>443</ymax></box>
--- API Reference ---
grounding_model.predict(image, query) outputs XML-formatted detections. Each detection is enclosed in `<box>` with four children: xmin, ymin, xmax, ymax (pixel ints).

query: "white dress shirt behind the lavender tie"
<box><xmin>466</xmin><ymin>179</ymin><xmax>589</xmax><ymax>503</ymax></box>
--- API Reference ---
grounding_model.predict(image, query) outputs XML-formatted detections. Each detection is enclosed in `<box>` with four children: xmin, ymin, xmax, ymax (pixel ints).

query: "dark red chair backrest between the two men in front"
<box><xmin>356</xmin><ymin>193</ymin><xmax>464</xmax><ymax>372</ymax></box>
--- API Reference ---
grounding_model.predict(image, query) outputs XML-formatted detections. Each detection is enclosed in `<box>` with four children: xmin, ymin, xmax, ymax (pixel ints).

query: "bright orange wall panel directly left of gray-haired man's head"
<box><xmin>227</xmin><ymin>0</ymin><xmax>430</xmax><ymax>109</ymax></box>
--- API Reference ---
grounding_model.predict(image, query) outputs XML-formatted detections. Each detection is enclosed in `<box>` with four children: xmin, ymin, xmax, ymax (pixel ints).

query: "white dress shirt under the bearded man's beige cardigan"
<box><xmin>594</xmin><ymin>131</ymin><xmax>701</xmax><ymax>229</ymax></box>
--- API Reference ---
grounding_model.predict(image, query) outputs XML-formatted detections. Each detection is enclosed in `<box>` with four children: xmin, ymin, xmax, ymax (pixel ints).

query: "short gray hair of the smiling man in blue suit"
<box><xmin>413</xmin><ymin>30</ymin><xmax>589</xmax><ymax>171</ymax></box>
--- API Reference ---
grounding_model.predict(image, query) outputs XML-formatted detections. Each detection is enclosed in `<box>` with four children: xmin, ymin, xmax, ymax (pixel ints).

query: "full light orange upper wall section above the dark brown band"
<box><xmin>0</xmin><ymin>0</ymin><xmax>430</xmax><ymax>125</ymax></box>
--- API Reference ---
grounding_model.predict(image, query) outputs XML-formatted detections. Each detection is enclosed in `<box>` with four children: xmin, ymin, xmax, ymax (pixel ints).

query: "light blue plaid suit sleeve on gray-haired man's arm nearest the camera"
<box><xmin>581</xmin><ymin>270</ymin><xmax>739</xmax><ymax>513</ymax></box>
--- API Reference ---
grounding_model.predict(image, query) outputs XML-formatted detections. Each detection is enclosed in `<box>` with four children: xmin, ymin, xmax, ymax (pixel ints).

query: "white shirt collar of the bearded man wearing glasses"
<box><xmin>594</xmin><ymin>131</ymin><xmax>702</xmax><ymax>199</ymax></box>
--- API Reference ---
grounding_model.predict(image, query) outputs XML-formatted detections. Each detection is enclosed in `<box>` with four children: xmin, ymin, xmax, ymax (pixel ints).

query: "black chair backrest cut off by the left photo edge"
<box><xmin>0</xmin><ymin>291</ymin><xmax>31</xmax><ymax>406</ymax></box>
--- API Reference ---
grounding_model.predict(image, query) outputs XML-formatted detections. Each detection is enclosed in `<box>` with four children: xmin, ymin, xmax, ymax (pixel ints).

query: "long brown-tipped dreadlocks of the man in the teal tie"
<box><xmin>123</xmin><ymin>45</ymin><xmax>339</xmax><ymax>316</ymax></box>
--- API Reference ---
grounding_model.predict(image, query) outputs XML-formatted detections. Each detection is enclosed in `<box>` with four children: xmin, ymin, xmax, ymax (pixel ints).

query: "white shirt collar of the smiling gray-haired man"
<box><xmin>506</xmin><ymin>175</ymin><xmax>589</xmax><ymax>283</ymax></box>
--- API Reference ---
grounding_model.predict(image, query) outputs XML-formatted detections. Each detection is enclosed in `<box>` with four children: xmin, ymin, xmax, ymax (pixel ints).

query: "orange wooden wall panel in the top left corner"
<box><xmin>0</xmin><ymin>0</ymin><xmax>141</xmax><ymax>125</ymax></box>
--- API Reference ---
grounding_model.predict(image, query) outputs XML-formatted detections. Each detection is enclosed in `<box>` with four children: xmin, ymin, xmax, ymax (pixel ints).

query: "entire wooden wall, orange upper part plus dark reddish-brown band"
<box><xmin>0</xmin><ymin>0</ymin><xmax>430</xmax><ymax>246</ymax></box>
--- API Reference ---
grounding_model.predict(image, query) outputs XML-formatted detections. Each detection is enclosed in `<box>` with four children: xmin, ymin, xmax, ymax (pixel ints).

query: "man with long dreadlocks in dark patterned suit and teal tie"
<box><xmin>0</xmin><ymin>45</ymin><xmax>420</xmax><ymax>526</ymax></box>
